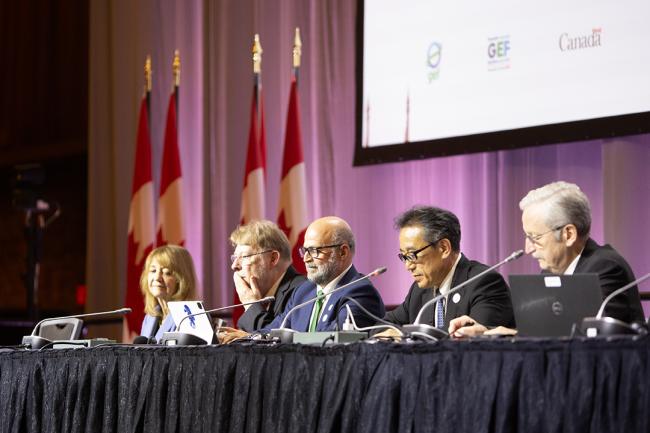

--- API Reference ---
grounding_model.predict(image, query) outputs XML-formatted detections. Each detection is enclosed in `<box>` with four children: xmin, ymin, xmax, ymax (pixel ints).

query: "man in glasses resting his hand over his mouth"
<box><xmin>230</xmin><ymin>220</ymin><xmax>306</xmax><ymax>332</ymax></box>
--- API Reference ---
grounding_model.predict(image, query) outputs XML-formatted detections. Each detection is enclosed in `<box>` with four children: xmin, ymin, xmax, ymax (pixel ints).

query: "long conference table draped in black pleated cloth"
<box><xmin>0</xmin><ymin>337</ymin><xmax>650</xmax><ymax>433</ymax></box>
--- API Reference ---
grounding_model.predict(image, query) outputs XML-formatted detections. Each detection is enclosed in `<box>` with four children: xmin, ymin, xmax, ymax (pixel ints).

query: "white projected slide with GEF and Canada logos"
<box><xmin>357</xmin><ymin>0</ymin><xmax>650</xmax><ymax>161</ymax></box>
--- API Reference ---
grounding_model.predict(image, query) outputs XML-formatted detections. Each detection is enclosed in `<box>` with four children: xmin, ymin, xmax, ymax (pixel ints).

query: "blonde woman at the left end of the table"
<box><xmin>140</xmin><ymin>245</ymin><xmax>196</xmax><ymax>341</ymax></box>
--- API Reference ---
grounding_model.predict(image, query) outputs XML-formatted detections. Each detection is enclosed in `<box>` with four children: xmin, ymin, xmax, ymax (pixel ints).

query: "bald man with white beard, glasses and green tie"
<box><xmin>265</xmin><ymin>217</ymin><xmax>384</xmax><ymax>332</ymax></box>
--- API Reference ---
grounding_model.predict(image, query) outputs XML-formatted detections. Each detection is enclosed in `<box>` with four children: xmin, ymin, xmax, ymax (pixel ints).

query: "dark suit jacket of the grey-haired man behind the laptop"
<box><xmin>574</xmin><ymin>238</ymin><xmax>645</xmax><ymax>323</ymax></box>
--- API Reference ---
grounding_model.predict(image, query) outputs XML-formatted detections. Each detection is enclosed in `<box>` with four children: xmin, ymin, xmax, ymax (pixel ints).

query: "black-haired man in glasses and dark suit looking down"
<box><xmin>385</xmin><ymin>206</ymin><xmax>514</xmax><ymax>330</ymax></box>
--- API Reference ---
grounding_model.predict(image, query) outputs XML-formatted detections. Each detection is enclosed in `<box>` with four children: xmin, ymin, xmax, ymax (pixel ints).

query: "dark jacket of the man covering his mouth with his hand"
<box><xmin>237</xmin><ymin>265</ymin><xmax>307</xmax><ymax>332</ymax></box>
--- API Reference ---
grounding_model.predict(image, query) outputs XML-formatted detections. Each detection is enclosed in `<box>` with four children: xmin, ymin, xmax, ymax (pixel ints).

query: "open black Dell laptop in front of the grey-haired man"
<box><xmin>509</xmin><ymin>274</ymin><xmax>603</xmax><ymax>337</ymax></box>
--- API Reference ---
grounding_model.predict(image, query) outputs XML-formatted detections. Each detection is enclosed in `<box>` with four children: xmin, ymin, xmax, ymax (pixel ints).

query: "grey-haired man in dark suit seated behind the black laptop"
<box><xmin>449</xmin><ymin>181</ymin><xmax>645</xmax><ymax>336</ymax></box>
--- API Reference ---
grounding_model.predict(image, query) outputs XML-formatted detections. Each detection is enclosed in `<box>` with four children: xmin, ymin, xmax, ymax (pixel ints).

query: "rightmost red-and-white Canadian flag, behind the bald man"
<box><xmin>278</xmin><ymin>76</ymin><xmax>309</xmax><ymax>274</ymax></box>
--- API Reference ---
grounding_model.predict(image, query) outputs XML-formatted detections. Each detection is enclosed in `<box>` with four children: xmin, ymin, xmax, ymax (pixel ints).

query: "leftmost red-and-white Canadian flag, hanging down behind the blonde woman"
<box><xmin>123</xmin><ymin>97</ymin><xmax>155</xmax><ymax>342</ymax></box>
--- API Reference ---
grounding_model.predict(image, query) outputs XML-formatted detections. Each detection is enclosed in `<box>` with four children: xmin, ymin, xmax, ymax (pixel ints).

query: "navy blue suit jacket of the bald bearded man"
<box><xmin>262</xmin><ymin>266</ymin><xmax>385</xmax><ymax>332</ymax></box>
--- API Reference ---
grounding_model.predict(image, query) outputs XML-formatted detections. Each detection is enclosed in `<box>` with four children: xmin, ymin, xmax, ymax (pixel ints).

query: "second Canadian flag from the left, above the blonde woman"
<box><xmin>156</xmin><ymin>92</ymin><xmax>185</xmax><ymax>246</ymax></box>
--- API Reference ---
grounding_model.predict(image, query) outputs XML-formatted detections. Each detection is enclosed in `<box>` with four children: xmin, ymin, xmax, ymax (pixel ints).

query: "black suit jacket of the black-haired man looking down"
<box><xmin>384</xmin><ymin>255</ymin><xmax>515</xmax><ymax>331</ymax></box>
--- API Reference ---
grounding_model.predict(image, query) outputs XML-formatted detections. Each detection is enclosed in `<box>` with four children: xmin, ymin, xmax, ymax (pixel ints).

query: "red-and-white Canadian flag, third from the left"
<box><xmin>233</xmin><ymin>83</ymin><xmax>266</xmax><ymax>326</ymax></box>
